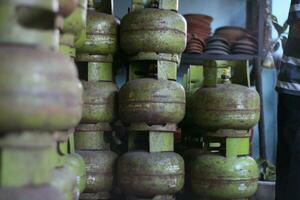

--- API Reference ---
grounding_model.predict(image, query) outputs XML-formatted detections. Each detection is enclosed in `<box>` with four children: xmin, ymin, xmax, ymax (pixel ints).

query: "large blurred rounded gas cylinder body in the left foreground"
<box><xmin>0</xmin><ymin>45</ymin><xmax>82</xmax><ymax>131</ymax></box>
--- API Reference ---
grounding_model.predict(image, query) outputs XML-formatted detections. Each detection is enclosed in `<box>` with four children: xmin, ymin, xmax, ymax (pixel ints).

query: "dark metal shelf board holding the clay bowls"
<box><xmin>181</xmin><ymin>53</ymin><xmax>258</xmax><ymax>65</ymax></box>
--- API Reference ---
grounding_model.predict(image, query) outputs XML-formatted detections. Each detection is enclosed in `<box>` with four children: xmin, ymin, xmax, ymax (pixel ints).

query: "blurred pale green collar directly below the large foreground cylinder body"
<box><xmin>0</xmin><ymin>132</ymin><xmax>55</xmax><ymax>187</ymax></box>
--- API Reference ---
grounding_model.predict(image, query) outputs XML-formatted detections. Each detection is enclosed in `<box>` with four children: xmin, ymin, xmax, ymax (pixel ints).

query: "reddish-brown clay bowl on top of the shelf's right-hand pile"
<box><xmin>215</xmin><ymin>26</ymin><xmax>249</xmax><ymax>43</ymax></box>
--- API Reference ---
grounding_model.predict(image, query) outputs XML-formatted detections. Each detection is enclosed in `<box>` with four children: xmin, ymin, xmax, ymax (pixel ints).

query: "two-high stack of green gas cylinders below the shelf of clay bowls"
<box><xmin>184</xmin><ymin>61</ymin><xmax>260</xmax><ymax>200</ymax></box>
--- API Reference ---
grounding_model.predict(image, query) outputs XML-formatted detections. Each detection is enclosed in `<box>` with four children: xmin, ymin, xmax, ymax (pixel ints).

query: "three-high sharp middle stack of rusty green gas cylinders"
<box><xmin>117</xmin><ymin>0</ymin><xmax>187</xmax><ymax>200</ymax></box>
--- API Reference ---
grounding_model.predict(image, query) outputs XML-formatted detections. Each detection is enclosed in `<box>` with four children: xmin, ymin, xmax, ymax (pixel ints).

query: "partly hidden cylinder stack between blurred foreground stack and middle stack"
<box><xmin>75</xmin><ymin>1</ymin><xmax>118</xmax><ymax>200</ymax></box>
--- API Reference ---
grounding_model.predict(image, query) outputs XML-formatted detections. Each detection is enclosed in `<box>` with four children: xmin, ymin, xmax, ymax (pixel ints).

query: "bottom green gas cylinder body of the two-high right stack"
<box><xmin>191</xmin><ymin>154</ymin><xmax>258</xmax><ymax>200</ymax></box>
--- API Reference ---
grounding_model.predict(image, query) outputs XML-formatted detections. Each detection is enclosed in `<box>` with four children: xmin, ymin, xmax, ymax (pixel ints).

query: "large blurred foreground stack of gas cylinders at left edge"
<box><xmin>0</xmin><ymin>0</ymin><xmax>82</xmax><ymax>200</ymax></box>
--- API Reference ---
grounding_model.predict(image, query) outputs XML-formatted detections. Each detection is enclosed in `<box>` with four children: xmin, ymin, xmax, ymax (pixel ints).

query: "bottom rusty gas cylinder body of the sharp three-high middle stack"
<box><xmin>117</xmin><ymin>151</ymin><xmax>184</xmax><ymax>198</ymax></box>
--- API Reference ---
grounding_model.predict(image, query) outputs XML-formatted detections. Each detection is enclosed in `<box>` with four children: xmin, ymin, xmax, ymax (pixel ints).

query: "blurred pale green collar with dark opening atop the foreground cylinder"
<box><xmin>0</xmin><ymin>0</ymin><xmax>59</xmax><ymax>49</ymax></box>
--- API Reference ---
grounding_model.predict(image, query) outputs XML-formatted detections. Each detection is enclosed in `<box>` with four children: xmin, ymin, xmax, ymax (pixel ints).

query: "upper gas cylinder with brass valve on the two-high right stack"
<box><xmin>193</xmin><ymin>62</ymin><xmax>260</xmax><ymax>130</ymax></box>
